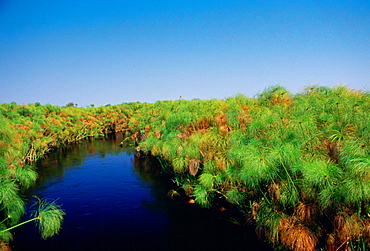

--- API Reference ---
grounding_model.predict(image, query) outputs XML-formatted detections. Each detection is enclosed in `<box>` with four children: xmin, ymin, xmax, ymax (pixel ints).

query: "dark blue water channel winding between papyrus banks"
<box><xmin>11</xmin><ymin>139</ymin><xmax>270</xmax><ymax>251</ymax></box>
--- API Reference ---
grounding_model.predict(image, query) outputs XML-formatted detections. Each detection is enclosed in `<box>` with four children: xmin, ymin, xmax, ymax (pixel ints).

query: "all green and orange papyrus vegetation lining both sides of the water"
<box><xmin>0</xmin><ymin>86</ymin><xmax>370</xmax><ymax>251</ymax></box>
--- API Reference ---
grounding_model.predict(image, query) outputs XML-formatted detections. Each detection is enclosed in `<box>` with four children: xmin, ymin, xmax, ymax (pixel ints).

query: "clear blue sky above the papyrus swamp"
<box><xmin>0</xmin><ymin>0</ymin><xmax>370</xmax><ymax>107</ymax></box>
